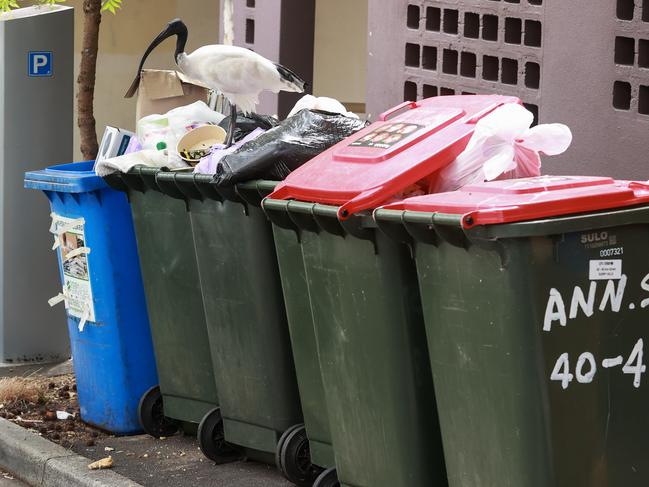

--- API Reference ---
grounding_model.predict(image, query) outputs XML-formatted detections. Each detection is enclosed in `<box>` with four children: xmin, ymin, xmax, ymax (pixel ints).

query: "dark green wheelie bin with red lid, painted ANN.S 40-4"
<box><xmin>375</xmin><ymin>176</ymin><xmax>649</xmax><ymax>487</ymax></box>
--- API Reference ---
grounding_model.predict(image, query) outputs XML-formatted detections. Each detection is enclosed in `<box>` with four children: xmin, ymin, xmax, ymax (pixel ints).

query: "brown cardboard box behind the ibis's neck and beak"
<box><xmin>135</xmin><ymin>69</ymin><xmax>210</xmax><ymax>122</ymax></box>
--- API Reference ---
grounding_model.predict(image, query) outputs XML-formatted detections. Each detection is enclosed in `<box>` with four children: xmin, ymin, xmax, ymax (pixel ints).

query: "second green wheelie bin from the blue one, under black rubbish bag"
<box><xmin>158</xmin><ymin>173</ymin><xmax>319</xmax><ymax>486</ymax></box>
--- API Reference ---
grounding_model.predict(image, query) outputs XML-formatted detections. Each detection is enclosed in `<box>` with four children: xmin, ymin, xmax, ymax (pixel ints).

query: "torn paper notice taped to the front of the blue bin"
<box><xmin>51</xmin><ymin>214</ymin><xmax>95</xmax><ymax>323</ymax></box>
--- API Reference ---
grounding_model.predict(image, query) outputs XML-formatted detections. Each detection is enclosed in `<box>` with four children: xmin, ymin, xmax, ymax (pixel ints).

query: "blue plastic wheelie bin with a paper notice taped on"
<box><xmin>25</xmin><ymin>161</ymin><xmax>158</xmax><ymax>434</ymax></box>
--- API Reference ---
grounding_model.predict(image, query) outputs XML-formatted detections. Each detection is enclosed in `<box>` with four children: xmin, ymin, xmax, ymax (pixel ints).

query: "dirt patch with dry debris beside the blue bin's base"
<box><xmin>0</xmin><ymin>374</ymin><xmax>111</xmax><ymax>448</ymax></box>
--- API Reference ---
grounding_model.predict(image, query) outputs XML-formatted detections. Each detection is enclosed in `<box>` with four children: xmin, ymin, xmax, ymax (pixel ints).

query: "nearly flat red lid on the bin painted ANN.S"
<box><xmin>382</xmin><ymin>176</ymin><xmax>649</xmax><ymax>228</ymax></box>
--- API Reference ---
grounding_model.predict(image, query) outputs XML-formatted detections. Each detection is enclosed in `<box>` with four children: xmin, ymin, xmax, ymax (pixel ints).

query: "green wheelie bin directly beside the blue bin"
<box><xmin>105</xmin><ymin>166</ymin><xmax>228</xmax><ymax>450</ymax></box>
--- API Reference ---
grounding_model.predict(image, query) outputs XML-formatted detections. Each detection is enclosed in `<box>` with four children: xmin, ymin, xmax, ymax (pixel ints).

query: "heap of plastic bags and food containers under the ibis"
<box><xmin>95</xmin><ymin>95</ymin><xmax>367</xmax><ymax>180</ymax></box>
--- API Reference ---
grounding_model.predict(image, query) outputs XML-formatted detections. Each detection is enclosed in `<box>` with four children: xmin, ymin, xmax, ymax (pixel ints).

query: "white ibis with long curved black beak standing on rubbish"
<box><xmin>126</xmin><ymin>19</ymin><xmax>306</xmax><ymax>146</ymax></box>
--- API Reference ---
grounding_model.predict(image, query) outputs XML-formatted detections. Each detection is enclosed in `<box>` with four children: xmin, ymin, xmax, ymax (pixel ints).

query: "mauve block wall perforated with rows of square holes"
<box><xmin>367</xmin><ymin>0</ymin><xmax>649</xmax><ymax>179</ymax></box>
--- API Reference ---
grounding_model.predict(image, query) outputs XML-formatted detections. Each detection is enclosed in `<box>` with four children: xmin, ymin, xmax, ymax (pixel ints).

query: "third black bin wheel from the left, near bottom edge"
<box><xmin>278</xmin><ymin>424</ymin><xmax>321</xmax><ymax>487</ymax></box>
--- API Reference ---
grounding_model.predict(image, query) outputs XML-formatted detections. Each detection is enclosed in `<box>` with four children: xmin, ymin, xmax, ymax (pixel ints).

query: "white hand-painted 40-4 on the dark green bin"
<box><xmin>550</xmin><ymin>338</ymin><xmax>647</xmax><ymax>389</ymax></box>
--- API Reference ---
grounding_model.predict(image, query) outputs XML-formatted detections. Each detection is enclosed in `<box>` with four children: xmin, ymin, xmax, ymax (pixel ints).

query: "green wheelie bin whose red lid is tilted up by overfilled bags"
<box><xmin>263</xmin><ymin>96</ymin><xmax>518</xmax><ymax>487</ymax></box>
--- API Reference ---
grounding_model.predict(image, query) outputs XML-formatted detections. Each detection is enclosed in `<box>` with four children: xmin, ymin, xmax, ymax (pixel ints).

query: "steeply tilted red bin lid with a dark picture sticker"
<box><xmin>270</xmin><ymin>95</ymin><xmax>520</xmax><ymax>219</ymax></box>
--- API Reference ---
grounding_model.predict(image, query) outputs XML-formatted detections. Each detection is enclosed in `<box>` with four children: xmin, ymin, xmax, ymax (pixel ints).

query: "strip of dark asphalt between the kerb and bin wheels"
<box><xmin>73</xmin><ymin>435</ymin><xmax>294</xmax><ymax>487</ymax></box>
